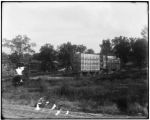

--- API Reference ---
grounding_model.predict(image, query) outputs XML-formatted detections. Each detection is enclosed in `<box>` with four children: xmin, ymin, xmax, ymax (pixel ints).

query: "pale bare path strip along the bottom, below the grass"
<box><xmin>2</xmin><ymin>103</ymin><xmax>145</xmax><ymax>120</ymax></box>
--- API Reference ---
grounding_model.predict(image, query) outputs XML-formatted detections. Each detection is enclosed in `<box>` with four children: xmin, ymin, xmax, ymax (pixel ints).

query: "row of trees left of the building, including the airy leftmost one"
<box><xmin>2</xmin><ymin>35</ymin><xmax>94</xmax><ymax>71</ymax></box>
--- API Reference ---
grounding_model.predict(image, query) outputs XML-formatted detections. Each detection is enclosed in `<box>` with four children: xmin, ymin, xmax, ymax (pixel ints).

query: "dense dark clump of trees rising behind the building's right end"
<box><xmin>100</xmin><ymin>36</ymin><xmax>148</xmax><ymax>67</ymax></box>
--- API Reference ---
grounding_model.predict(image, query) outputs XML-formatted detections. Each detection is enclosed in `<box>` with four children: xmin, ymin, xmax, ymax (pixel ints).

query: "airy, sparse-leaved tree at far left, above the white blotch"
<box><xmin>2</xmin><ymin>35</ymin><xmax>36</xmax><ymax>65</ymax></box>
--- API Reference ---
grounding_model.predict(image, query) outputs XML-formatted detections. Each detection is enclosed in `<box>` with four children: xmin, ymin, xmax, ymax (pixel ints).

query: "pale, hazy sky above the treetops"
<box><xmin>2</xmin><ymin>2</ymin><xmax>148</xmax><ymax>53</ymax></box>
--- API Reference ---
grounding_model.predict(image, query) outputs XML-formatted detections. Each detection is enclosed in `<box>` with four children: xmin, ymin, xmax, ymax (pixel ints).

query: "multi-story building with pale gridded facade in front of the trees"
<box><xmin>73</xmin><ymin>53</ymin><xmax>120</xmax><ymax>73</ymax></box>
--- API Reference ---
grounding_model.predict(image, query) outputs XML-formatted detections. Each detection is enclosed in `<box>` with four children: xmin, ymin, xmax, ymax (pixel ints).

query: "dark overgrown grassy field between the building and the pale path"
<box><xmin>2</xmin><ymin>70</ymin><xmax>148</xmax><ymax>116</ymax></box>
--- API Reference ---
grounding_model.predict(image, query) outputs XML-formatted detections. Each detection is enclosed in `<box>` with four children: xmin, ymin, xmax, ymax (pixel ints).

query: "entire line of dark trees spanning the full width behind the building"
<box><xmin>2</xmin><ymin>27</ymin><xmax>148</xmax><ymax>71</ymax></box>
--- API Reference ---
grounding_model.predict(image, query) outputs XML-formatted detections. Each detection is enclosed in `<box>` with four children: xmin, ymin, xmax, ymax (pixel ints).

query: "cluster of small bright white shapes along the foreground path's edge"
<box><xmin>35</xmin><ymin>98</ymin><xmax>69</xmax><ymax>117</ymax></box>
